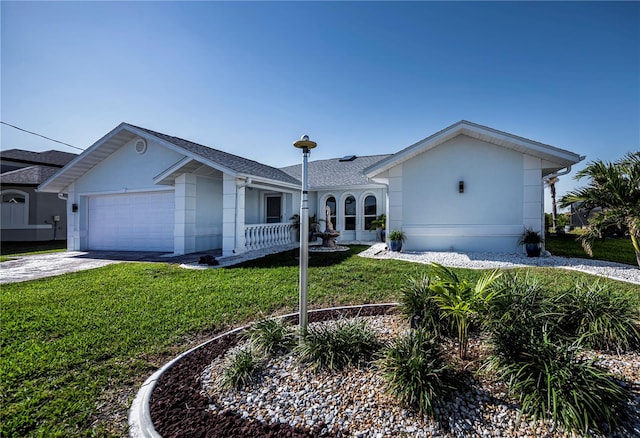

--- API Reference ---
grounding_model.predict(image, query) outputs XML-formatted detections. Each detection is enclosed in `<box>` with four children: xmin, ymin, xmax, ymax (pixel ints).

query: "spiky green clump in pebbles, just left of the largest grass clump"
<box><xmin>378</xmin><ymin>329</ymin><xmax>454</xmax><ymax>417</ymax></box>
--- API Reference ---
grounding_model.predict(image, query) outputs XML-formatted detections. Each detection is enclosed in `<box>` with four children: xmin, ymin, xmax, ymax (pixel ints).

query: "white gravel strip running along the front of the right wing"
<box><xmin>359</xmin><ymin>243</ymin><xmax>640</xmax><ymax>285</ymax></box>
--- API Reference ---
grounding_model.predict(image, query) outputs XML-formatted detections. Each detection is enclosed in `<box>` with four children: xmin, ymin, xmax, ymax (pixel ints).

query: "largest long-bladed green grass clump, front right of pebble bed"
<box><xmin>485</xmin><ymin>274</ymin><xmax>637</xmax><ymax>433</ymax></box>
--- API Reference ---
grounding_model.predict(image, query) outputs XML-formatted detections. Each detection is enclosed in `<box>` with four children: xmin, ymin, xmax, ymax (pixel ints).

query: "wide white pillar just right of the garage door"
<box><xmin>173</xmin><ymin>173</ymin><xmax>196</xmax><ymax>254</ymax></box>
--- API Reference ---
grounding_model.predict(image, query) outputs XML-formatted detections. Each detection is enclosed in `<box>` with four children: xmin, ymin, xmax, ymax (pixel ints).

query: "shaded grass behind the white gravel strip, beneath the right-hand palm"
<box><xmin>545</xmin><ymin>234</ymin><xmax>638</xmax><ymax>266</ymax></box>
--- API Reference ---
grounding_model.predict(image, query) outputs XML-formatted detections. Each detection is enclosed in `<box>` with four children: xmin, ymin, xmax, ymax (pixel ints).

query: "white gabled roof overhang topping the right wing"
<box><xmin>364</xmin><ymin>120</ymin><xmax>584</xmax><ymax>178</ymax></box>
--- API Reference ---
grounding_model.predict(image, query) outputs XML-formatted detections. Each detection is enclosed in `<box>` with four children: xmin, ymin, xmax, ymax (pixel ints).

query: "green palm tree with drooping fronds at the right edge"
<box><xmin>561</xmin><ymin>152</ymin><xmax>640</xmax><ymax>266</ymax></box>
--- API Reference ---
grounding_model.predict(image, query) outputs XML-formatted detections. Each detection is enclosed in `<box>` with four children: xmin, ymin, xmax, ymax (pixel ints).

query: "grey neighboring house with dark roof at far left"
<box><xmin>0</xmin><ymin>149</ymin><xmax>77</xmax><ymax>242</ymax></box>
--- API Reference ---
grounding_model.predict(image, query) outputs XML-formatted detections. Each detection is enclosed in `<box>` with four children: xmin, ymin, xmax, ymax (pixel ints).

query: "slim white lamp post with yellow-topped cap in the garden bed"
<box><xmin>293</xmin><ymin>135</ymin><xmax>317</xmax><ymax>344</ymax></box>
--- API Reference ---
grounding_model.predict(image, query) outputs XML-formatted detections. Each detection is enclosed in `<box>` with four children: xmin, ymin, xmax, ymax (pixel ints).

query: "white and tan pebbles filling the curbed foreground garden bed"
<box><xmin>201</xmin><ymin>315</ymin><xmax>640</xmax><ymax>438</ymax></box>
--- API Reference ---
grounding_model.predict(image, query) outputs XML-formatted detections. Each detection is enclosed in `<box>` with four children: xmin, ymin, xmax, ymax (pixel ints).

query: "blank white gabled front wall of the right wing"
<box><xmin>398</xmin><ymin>135</ymin><xmax>542</xmax><ymax>252</ymax></box>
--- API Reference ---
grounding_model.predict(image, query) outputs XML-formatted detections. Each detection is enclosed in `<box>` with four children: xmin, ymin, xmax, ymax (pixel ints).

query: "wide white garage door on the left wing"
<box><xmin>87</xmin><ymin>192</ymin><xmax>174</xmax><ymax>252</ymax></box>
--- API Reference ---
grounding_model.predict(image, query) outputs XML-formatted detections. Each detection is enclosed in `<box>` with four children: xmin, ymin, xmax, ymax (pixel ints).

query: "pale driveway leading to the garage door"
<box><xmin>0</xmin><ymin>251</ymin><xmax>218</xmax><ymax>284</ymax></box>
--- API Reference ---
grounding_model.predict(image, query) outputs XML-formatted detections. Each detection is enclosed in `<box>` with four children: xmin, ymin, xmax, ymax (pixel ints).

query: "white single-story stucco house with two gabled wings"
<box><xmin>39</xmin><ymin>121</ymin><xmax>584</xmax><ymax>256</ymax></box>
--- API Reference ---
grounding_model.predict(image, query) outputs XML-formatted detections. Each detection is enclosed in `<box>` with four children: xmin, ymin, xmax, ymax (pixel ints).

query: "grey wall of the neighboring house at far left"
<box><xmin>0</xmin><ymin>186</ymin><xmax>67</xmax><ymax>242</ymax></box>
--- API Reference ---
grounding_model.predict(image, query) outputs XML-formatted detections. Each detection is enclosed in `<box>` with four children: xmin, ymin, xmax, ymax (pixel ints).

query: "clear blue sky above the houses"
<box><xmin>0</xmin><ymin>1</ymin><xmax>640</xmax><ymax>209</ymax></box>
